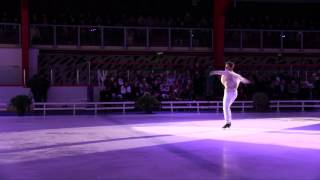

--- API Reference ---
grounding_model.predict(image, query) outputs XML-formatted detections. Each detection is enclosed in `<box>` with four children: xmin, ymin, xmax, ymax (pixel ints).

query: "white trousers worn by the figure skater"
<box><xmin>223</xmin><ymin>89</ymin><xmax>238</xmax><ymax>123</ymax></box>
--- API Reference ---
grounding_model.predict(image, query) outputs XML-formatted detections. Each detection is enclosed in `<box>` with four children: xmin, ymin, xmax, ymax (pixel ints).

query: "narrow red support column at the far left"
<box><xmin>20</xmin><ymin>0</ymin><xmax>29</xmax><ymax>85</ymax></box>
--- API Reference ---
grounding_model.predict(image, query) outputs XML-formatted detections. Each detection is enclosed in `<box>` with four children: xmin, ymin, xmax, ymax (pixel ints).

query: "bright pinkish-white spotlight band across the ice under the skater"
<box><xmin>0</xmin><ymin>117</ymin><xmax>320</xmax><ymax>164</ymax></box>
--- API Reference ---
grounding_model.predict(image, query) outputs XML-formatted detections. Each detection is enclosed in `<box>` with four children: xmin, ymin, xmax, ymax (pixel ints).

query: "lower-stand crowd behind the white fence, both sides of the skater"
<box><xmin>100</xmin><ymin>66</ymin><xmax>320</xmax><ymax>101</ymax></box>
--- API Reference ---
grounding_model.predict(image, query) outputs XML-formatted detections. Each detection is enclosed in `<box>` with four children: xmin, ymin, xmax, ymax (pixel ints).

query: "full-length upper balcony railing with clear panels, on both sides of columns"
<box><xmin>0</xmin><ymin>23</ymin><xmax>320</xmax><ymax>51</ymax></box>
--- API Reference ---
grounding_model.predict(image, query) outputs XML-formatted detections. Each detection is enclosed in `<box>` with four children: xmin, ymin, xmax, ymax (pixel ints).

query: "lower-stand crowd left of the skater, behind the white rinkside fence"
<box><xmin>100</xmin><ymin>71</ymin><xmax>205</xmax><ymax>101</ymax></box>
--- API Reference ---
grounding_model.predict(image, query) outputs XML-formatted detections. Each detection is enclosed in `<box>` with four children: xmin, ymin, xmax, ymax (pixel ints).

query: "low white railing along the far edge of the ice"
<box><xmin>0</xmin><ymin>100</ymin><xmax>320</xmax><ymax>116</ymax></box>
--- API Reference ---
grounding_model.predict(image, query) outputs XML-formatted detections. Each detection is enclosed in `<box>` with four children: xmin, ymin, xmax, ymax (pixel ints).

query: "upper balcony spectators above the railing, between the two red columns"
<box><xmin>31</xmin><ymin>12</ymin><xmax>212</xmax><ymax>27</ymax></box>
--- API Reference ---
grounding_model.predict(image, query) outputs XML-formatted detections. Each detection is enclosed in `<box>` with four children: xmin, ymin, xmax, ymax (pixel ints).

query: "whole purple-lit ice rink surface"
<box><xmin>0</xmin><ymin>112</ymin><xmax>320</xmax><ymax>180</ymax></box>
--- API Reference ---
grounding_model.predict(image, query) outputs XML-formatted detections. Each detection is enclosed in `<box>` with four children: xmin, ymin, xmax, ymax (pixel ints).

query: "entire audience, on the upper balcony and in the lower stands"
<box><xmin>0</xmin><ymin>1</ymin><xmax>320</xmax><ymax>100</ymax></box>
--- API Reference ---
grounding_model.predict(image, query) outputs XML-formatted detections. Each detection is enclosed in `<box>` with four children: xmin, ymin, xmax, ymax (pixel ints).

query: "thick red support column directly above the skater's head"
<box><xmin>213</xmin><ymin>0</ymin><xmax>230</xmax><ymax>68</ymax></box>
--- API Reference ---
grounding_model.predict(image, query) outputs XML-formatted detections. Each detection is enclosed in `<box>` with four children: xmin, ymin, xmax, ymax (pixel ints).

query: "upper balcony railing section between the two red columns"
<box><xmin>30</xmin><ymin>24</ymin><xmax>212</xmax><ymax>49</ymax></box>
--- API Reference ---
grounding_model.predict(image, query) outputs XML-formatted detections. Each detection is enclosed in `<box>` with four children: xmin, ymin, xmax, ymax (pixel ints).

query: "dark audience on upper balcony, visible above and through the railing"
<box><xmin>0</xmin><ymin>7</ymin><xmax>320</xmax><ymax>49</ymax></box>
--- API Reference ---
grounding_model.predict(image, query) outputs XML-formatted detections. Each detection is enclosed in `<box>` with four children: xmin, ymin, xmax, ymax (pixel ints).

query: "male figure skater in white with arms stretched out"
<box><xmin>210</xmin><ymin>62</ymin><xmax>250</xmax><ymax>129</ymax></box>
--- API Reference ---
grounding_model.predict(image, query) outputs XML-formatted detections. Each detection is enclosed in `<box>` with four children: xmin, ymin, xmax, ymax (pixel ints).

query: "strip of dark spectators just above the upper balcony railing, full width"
<box><xmin>0</xmin><ymin>9</ymin><xmax>320</xmax><ymax>30</ymax></box>
